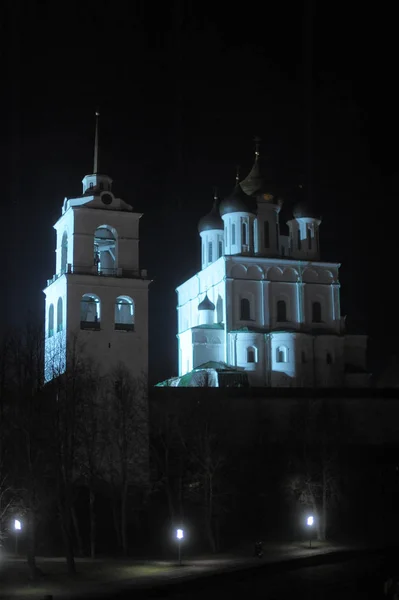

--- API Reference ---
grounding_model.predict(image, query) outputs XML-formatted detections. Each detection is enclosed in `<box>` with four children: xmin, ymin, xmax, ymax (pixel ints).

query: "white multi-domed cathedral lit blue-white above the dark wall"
<box><xmin>176</xmin><ymin>144</ymin><xmax>369</xmax><ymax>387</ymax></box>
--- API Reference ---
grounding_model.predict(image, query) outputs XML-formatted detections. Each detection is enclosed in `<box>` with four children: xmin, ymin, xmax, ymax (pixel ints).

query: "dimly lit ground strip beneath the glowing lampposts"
<box><xmin>0</xmin><ymin>542</ymin><xmax>368</xmax><ymax>600</ymax></box>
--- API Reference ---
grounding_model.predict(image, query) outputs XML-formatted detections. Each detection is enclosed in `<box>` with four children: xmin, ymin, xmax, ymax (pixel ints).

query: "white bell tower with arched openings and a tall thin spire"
<box><xmin>44</xmin><ymin>113</ymin><xmax>150</xmax><ymax>381</ymax></box>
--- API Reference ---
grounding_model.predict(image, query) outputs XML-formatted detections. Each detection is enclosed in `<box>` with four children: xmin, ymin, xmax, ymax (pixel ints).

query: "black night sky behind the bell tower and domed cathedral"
<box><xmin>0</xmin><ymin>0</ymin><xmax>399</xmax><ymax>380</ymax></box>
